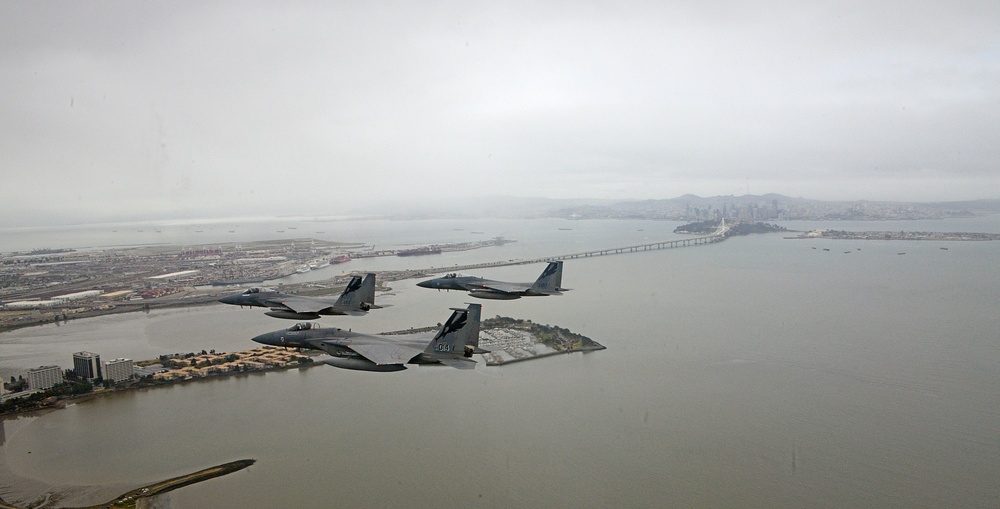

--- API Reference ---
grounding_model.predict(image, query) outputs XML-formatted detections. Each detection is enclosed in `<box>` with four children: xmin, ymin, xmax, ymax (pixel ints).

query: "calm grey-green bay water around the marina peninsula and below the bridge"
<box><xmin>0</xmin><ymin>216</ymin><xmax>1000</xmax><ymax>508</ymax></box>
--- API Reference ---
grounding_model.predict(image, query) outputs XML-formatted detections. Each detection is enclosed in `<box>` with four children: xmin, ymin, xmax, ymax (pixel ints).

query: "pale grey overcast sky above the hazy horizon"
<box><xmin>0</xmin><ymin>0</ymin><xmax>1000</xmax><ymax>226</ymax></box>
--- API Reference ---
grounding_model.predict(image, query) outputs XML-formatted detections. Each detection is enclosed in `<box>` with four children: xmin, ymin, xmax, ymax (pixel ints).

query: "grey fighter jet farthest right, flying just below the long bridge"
<box><xmin>417</xmin><ymin>260</ymin><xmax>568</xmax><ymax>300</ymax></box>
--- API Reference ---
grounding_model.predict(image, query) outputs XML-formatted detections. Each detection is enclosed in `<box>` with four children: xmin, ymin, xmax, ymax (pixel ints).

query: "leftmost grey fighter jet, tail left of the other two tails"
<box><xmin>219</xmin><ymin>274</ymin><xmax>379</xmax><ymax>320</ymax></box>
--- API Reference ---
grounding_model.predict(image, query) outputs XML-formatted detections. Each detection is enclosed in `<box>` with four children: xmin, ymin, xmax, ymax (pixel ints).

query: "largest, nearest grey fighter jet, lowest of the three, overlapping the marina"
<box><xmin>253</xmin><ymin>304</ymin><xmax>486</xmax><ymax>371</ymax></box>
